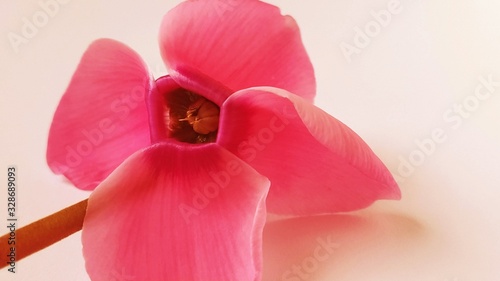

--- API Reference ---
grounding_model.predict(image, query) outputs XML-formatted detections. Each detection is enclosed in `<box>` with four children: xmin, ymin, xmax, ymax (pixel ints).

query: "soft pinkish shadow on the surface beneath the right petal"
<box><xmin>263</xmin><ymin>212</ymin><xmax>426</xmax><ymax>281</ymax></box>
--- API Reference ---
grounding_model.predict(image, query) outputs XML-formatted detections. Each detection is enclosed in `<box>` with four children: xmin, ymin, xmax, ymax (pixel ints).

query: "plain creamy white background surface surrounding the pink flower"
<box><xmin>0</xmin><ymin>0</ymin><xmax>500</xmax><ymax>281</ymax></box>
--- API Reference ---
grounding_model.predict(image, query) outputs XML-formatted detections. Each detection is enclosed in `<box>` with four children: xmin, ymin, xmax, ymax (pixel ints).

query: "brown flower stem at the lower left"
<box><xmin>0</xmin><ymin>199</ymin><xmax>87</xmax><ymax>268</ymax></box>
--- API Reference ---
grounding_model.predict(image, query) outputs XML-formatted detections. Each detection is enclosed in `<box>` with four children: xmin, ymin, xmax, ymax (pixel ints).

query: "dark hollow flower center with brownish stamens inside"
<box><xmin>166</xmin><ymin>89</ymin><xmax>220</xmax><ymax>143</ymax></box>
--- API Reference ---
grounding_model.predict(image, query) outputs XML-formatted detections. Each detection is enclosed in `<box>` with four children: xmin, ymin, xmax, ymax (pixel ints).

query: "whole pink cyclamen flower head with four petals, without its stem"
<box><xmin>47</xmin><ymin>0</ymin><xmax>400</xmax><ymax>281</ymax></box>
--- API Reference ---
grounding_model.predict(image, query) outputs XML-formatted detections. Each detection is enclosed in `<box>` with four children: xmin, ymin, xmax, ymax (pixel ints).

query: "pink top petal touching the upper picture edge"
<box><xmin>160</xmin><ymin>0</ymin><xmax>316</xmax><ymax>101</ymax></box>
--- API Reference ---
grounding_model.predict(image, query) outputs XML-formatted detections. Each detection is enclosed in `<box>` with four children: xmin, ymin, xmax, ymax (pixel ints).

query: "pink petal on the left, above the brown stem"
<box><xmin>47</xmin><ymin>39</ymin><xmax>152</xmax><ymax>189</ymax></box>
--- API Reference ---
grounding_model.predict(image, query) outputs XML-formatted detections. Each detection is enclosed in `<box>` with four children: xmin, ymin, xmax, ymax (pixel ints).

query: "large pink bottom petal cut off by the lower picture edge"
<box><xmin>82</xmin><ymin>143</ymin><xmax>269</xmax><ymax>281</ymax></box>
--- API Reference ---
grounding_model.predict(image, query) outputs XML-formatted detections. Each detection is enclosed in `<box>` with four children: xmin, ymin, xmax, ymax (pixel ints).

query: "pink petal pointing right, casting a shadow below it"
<box><xmin>217</xmin><ymin>88</ymin><xmax>400</xmax><ymax>215</ymax></box>
